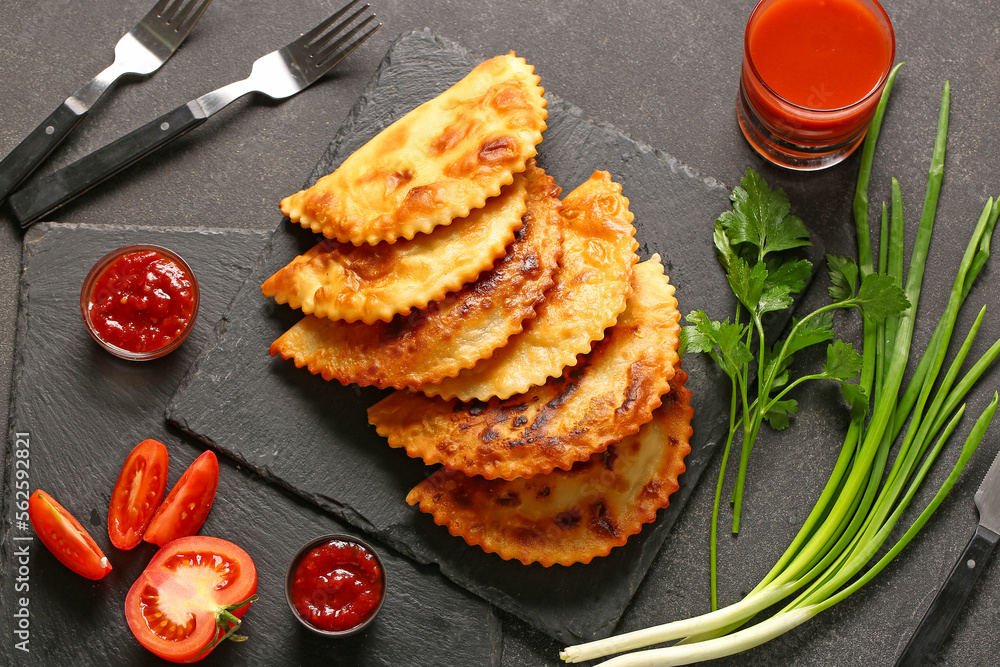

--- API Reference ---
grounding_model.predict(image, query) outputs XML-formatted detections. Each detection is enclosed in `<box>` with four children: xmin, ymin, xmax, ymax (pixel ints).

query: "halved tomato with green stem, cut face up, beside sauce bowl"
<box><xmin>125</xmin><ymin>535</ymin><xmax>257</xmax><ymax>662</ymax></box>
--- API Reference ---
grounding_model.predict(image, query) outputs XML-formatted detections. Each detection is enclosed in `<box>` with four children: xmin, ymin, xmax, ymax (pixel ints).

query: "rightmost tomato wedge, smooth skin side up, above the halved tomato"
<box><xmin>143</xmin><ymin>450</ymin><xmax>219</xmax><ymax>547</ymax></box>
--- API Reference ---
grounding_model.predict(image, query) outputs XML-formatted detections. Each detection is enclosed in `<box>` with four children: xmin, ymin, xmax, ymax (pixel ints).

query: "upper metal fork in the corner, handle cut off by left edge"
<box><xmin>0</xmin><ymin>0</ymin><xmax>212</xmax><ymax>202</ymax></box>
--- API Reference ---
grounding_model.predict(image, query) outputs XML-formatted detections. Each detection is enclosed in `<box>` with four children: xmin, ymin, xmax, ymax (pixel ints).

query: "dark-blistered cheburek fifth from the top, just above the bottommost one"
<box><xmin>368</xmin><ymin>255</ymin><xmax>680</xmax><ymax>479</ymax></box>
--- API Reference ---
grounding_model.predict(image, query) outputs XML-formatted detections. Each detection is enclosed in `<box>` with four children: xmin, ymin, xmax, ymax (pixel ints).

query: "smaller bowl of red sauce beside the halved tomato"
<box><xmin>285</xmin><ymin>534</ymin><xmax>385</xmax><ymax>637</ymax></box>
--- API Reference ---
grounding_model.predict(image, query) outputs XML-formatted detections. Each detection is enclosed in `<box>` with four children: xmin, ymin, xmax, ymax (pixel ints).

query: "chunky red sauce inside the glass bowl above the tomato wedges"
<box><xmin>87</xmin><ymin>250</ymin><xmax>195</xmax><ymax>353</ymax></box>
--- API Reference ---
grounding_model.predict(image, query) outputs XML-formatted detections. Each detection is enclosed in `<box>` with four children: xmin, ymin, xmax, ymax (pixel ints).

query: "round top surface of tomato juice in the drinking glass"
<box><xmin>748</xmin><ymin>0</ymin><xmax>893</xmax><ymax>109</ymax></box>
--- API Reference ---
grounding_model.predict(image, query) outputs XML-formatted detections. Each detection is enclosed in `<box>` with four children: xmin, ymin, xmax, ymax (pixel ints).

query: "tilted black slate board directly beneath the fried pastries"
<box><xmin>167</xmin><ymin>31</ymin><xmax>804</xmax><ymax>642</ymax></box>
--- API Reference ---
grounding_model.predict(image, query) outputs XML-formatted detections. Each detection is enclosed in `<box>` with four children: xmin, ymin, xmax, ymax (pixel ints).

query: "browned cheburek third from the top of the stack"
<box><xmin>270</xmin><ymin>166</ymin><xmax>562</xmax><ymax>388</ymax></box>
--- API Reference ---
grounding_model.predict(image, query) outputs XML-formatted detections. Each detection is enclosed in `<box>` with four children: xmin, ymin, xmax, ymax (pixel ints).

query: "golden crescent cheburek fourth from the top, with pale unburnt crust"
<box><xmin>422</xmin><ymin>171</ymin><xmax>639</xmax><ymax>401</ymax></box>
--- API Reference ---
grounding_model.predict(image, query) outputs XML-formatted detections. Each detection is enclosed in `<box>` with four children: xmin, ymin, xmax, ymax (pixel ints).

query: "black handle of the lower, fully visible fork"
<box><xmin>9</xmin><ymin>101</ymin><xmax>208</xmax><ymax>227</ymax></box>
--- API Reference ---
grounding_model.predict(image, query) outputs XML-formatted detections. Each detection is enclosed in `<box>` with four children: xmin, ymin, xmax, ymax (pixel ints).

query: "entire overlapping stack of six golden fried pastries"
<box><xmin>262</xmin><ymin>53</ymin><xmax>692</xmax><ymax>566</ymax></box>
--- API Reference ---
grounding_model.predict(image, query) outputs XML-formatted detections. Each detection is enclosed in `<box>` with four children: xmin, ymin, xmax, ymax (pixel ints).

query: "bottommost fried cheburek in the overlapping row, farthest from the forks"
<box><xmin>406</xmin><ymin>369</ymin><xmax>694</xmax><ymax>567</ymax></box>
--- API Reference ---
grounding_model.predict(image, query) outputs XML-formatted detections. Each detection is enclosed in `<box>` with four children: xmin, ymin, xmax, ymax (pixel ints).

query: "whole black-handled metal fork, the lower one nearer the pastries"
<box><xmin>10</xmin><ymin>0</ymin><xmax>382</xmax><ymax>227</ymax></box>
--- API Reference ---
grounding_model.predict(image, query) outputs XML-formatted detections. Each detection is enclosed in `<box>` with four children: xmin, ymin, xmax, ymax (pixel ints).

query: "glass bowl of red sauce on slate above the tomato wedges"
<box><xmin>80</xmin><ymin>244</ymin><xmax>199</xmax><ymax>361</ymax></box>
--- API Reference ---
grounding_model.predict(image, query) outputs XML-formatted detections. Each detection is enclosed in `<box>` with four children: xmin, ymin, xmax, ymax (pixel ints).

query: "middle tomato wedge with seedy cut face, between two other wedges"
<box><xmin>108</xmin><ymin>440</ymin><xmax>170</xmax><ymax>549</ymax></box>
